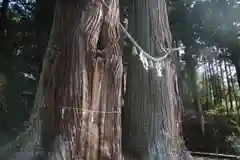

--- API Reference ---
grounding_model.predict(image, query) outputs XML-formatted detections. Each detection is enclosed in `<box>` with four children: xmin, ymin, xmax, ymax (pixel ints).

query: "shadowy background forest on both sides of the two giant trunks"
<box><xmin>0</xmin><ymin>0</ymin><xmax>240</xmax><ymax>159</ymax></box>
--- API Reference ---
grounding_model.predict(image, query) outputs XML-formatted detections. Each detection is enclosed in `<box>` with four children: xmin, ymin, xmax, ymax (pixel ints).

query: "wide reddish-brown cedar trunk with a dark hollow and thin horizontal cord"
<box><xmin>35</xmin><ymin>0</ymin><xmax>122</xmax><ymax>160</ymax></box>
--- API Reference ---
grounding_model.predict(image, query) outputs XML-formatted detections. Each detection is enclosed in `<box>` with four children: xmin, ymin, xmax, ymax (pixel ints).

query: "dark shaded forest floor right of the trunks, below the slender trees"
<box><xmin>183</xmin><ymin>109</ymin><xmax>240</xmax><ymax>155</ymax></box>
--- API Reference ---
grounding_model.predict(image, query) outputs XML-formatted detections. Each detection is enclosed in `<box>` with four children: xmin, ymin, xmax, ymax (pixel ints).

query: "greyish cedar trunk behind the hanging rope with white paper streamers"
<box><xmin>123</xmin><ymin>0</ymin><xmax>188</xmax><ymax>160</ymax></box>
